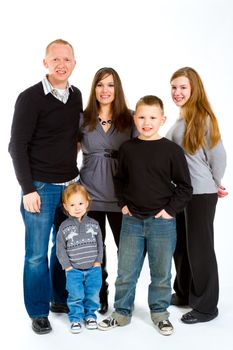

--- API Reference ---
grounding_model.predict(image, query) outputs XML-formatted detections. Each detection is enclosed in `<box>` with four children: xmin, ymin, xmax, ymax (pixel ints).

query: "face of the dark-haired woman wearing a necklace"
<box><xmin>95</xmin><ymin>74</ymin><xmax>115</xmax><ymax>105</ymax></box>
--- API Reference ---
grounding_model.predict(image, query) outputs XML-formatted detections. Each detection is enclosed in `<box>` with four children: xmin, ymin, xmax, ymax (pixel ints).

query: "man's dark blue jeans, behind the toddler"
<box><xmin>21</xmin><ymin>181</ymin><xmax>67</xmax><ymax>318</ymax></box>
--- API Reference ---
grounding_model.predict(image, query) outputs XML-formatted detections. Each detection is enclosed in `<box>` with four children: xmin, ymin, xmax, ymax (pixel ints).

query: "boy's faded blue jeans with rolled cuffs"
<box><xmin>113</xmin><ymin>215</ymin><xmax>176</xmax><ymax>326</ymax></box>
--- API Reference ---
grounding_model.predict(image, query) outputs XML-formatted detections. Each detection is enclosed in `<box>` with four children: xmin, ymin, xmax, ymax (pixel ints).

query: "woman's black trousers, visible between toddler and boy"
<box><xmin>88</xmin><ymin>211</ymin><xmax>122</xmax><ymax>303</ymax></box>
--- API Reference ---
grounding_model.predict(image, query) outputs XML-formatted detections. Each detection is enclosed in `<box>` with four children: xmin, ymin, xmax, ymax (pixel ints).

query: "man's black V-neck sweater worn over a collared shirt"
<box><xmin>9</xmin><ymin>82</ymin><xmax>82</xmax><ymax>194</ymax></box>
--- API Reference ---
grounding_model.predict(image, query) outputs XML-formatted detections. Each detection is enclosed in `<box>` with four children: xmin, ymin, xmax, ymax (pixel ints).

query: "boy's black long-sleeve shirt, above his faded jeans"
<box><xmin>115</xmin><ymin>138</ymin><xmax>192</xmax><ymax>218</ymax></box>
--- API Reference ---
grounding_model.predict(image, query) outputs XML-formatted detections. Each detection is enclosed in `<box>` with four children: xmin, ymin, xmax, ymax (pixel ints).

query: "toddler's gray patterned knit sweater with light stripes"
<box><xmin>56</xmin><ymin>215</ymin><xmax>103</xmax><ymax>269</ymax></box>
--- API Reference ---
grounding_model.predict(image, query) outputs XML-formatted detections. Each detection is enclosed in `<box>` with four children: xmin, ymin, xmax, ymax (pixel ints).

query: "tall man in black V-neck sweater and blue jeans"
<box><xmin>9</xmin><ymin>39</ymin><xmax>82</xmax><ymax>334</ymax></box>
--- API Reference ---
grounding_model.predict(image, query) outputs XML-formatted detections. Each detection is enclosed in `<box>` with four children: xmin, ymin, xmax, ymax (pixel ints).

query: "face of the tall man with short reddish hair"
<box><xmin>43</xmin><ymin>44</ymin><xmax>76</xmax><ymax>89</ymax></box>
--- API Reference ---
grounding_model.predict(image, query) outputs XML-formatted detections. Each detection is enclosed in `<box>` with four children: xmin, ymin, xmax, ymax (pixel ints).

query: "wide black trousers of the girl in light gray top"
<box><xmin>174</xmin><ymin>193</ymin><xmax>219</xmax><ymax>314</ymax></box>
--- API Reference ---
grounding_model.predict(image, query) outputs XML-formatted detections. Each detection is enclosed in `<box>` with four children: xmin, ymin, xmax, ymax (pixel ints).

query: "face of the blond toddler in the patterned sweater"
<box><xmin>64</xmin><ymin>193</ymin><xmax>89</xmax><ymax>221</ymax></box>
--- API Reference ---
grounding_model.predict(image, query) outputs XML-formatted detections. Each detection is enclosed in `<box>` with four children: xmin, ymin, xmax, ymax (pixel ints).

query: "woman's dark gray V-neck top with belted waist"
<box><xmin>79</xmin><ymin>118</ymin><xmax>138</xmax><ymax>212</ymax></box>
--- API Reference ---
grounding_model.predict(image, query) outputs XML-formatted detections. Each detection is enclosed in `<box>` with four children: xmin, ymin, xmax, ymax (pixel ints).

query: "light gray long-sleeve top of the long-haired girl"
<box><xmin>166</xmin><ymin>118</ymin><xmax>226</xmax><ymax>194</ymax></box>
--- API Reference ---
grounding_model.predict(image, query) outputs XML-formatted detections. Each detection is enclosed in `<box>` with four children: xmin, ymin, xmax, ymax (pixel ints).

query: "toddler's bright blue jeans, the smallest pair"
<box><xmin>66</xmin><ymin>266</ymin><xmax>102</xmax><ymax>322</ymax></box>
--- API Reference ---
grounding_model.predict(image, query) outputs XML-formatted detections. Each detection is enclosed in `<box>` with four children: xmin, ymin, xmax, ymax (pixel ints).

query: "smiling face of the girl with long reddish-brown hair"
<box><xmin>171</xmin><ymin>76</ymin><xmax>191</xmax><ymax>107</ymax></box>
